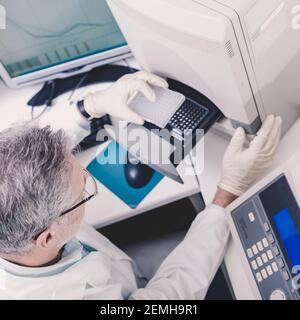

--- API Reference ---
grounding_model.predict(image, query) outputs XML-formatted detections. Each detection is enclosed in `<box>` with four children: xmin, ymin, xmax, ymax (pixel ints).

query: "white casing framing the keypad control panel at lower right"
<box><xmin>226</xmin><ymin>150</ymin><xmax>300</xmax><ymax>300</ymax></box>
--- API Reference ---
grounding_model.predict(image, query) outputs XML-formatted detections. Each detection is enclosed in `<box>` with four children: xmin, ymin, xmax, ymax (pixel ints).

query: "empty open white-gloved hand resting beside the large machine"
<box><xmin>219</xmin><ymin>115</ymin><xmax>282</xmax><ymax>196</ymax></box>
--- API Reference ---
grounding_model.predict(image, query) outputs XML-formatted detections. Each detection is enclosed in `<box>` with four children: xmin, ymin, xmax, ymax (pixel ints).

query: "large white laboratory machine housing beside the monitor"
<box><xmin>107</xmin><ymin>0</ymin><xmax>300</xmax><ymax>133</ymax></box>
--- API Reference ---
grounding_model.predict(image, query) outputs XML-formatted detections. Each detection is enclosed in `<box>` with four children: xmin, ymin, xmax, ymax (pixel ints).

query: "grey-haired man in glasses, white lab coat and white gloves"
<box><xmin>0</xmin><ymin>72</ymin><xmax>281</xmax><ymax>300</ymax></box>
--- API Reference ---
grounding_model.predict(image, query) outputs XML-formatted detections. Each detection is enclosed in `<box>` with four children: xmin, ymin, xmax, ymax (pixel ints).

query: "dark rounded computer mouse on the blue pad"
<box><xmin>124</xmin><ymin>156</ymin><xmax>154</xmax><ymax>189</ymax></box>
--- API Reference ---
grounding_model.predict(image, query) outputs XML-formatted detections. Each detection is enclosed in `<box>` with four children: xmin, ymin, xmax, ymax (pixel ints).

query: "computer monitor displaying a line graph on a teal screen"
<box><xmin>0</xmin><ymin>0</ymin><xmax>131</xmax><ymax>88</ymax></box>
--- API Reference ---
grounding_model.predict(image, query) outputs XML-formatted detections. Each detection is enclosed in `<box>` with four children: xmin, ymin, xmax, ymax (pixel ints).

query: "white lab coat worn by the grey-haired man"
<box><xmin>0</xmin><ymin>108</ymin><xmax>229</xmax><ymax>300</ymax></box>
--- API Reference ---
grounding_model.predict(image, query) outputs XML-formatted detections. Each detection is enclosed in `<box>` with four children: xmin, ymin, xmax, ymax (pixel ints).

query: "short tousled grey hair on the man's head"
<box><xmin>0</xmin><ymin>123</ymin><xmax>72</xmax><ymax>254</ymax></box>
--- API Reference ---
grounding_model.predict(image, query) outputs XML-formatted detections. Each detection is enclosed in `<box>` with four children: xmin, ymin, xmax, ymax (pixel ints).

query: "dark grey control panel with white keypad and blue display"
<box><xmin>231</xmin><ymin>175</ymin><xmax>300</xmax><ymax>300</ymax></box>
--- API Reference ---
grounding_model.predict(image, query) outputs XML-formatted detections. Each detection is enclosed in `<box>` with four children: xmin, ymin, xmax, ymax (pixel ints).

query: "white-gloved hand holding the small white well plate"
<box><xmin>84</xmin><ymin>71</ymin><xmax>168</xmax><ymax>124</ymax></box>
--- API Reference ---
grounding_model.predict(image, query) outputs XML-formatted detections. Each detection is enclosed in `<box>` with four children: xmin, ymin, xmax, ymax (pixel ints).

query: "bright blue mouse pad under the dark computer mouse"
<box><xmin>87</xmin><ymin>141</ymin><xmax>163</xmax><ymax>209</ymax></box>
